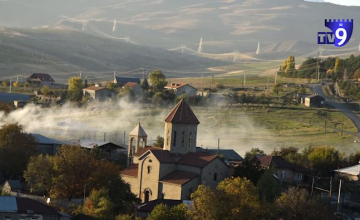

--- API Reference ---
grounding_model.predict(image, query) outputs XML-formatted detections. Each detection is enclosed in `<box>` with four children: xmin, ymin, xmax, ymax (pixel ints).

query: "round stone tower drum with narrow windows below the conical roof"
<box><xmin>164</xmin><ymin>122</ymin><xmax>197</xmax><ymax>154</ymax></box>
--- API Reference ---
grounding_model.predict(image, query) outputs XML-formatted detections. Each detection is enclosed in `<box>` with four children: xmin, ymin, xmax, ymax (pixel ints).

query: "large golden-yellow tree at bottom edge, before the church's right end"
<box><xmin>191</xmin><ymin>177</ymin><xmax>262</xmax><ymax>219</ymax></box>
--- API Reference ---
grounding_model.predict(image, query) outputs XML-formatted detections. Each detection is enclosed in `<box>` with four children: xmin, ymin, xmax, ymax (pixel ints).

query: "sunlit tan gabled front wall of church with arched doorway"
<box><xmin>138</xmin><ymin>153</ymin><xmax>160</xmax><ymax>201</ymax></box>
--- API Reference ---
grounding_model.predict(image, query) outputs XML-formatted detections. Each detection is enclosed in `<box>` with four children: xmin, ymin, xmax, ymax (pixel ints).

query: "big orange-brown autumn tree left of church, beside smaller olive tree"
<box><xmin>50</xmin><ymin>145</ymin><xmax>94</xmax><ymax>199</ymax></box>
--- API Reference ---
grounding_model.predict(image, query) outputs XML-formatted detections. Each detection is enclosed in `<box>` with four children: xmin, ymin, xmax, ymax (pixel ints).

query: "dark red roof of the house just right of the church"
<box><xmin>259</xmin><ymin>156</ymin><xmax>311</xmax><ymax>172</ymax></box>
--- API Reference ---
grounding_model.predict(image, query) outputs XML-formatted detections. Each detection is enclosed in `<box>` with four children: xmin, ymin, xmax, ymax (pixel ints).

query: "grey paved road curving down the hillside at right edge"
<box><xmin>310</xmin><ymin>84</ymin><xmax>360</xmax><ymax>134</ymax></box>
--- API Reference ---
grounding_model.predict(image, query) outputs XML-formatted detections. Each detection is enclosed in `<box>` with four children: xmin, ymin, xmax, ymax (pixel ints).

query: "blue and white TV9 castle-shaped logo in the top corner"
<box><xmin>318</xmin><ymin>19</ymin><xmax>354</xmax><ymax>47</ymax></box>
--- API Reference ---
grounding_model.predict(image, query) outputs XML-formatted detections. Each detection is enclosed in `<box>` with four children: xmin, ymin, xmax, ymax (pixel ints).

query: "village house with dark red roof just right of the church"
<box><xmin>259</xmin><ymin>156</ymin><xmax>311</xmax><ymax>183</ymax></box>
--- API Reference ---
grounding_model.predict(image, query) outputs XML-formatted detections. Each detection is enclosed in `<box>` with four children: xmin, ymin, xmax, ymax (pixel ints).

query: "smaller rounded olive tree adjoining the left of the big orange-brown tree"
<box><xmin>24</xmin><ymin>155</ymin><xmax>54</xmax><ymax>195</ymax></box>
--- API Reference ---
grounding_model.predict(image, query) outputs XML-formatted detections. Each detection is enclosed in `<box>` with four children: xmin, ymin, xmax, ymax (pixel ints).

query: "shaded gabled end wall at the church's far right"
<box><xmin>201</xmin><ymin>158</ymin><xmax>229</xmax><ymax>188</ymax></box>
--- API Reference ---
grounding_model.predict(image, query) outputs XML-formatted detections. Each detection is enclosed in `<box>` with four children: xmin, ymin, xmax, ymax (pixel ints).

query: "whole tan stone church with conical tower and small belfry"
<box><xmin>121</xmin><ymin>100</ymin><xmax>230</xmax><ymax>202</ymax></box>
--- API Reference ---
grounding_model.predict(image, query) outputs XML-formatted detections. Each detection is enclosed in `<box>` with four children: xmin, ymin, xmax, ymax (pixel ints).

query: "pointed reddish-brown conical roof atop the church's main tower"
<box><xmin>165</xmin><ymin>99</ymin><xmax>200</xmax><ymax>125</ymax></box>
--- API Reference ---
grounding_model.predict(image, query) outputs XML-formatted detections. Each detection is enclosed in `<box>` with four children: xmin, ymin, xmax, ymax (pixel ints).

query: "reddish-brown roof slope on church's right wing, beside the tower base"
<box><xmin>178</xmin><ymin>152</ymin><xmax>217</xmax><ymax>168</ymax></box>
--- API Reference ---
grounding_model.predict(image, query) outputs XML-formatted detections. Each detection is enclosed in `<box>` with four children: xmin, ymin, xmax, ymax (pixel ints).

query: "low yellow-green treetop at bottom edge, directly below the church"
<box><xmin>148</xmin><ymin>204</ymin><xmax>189</xmax><ymax>220</ymax></box>
